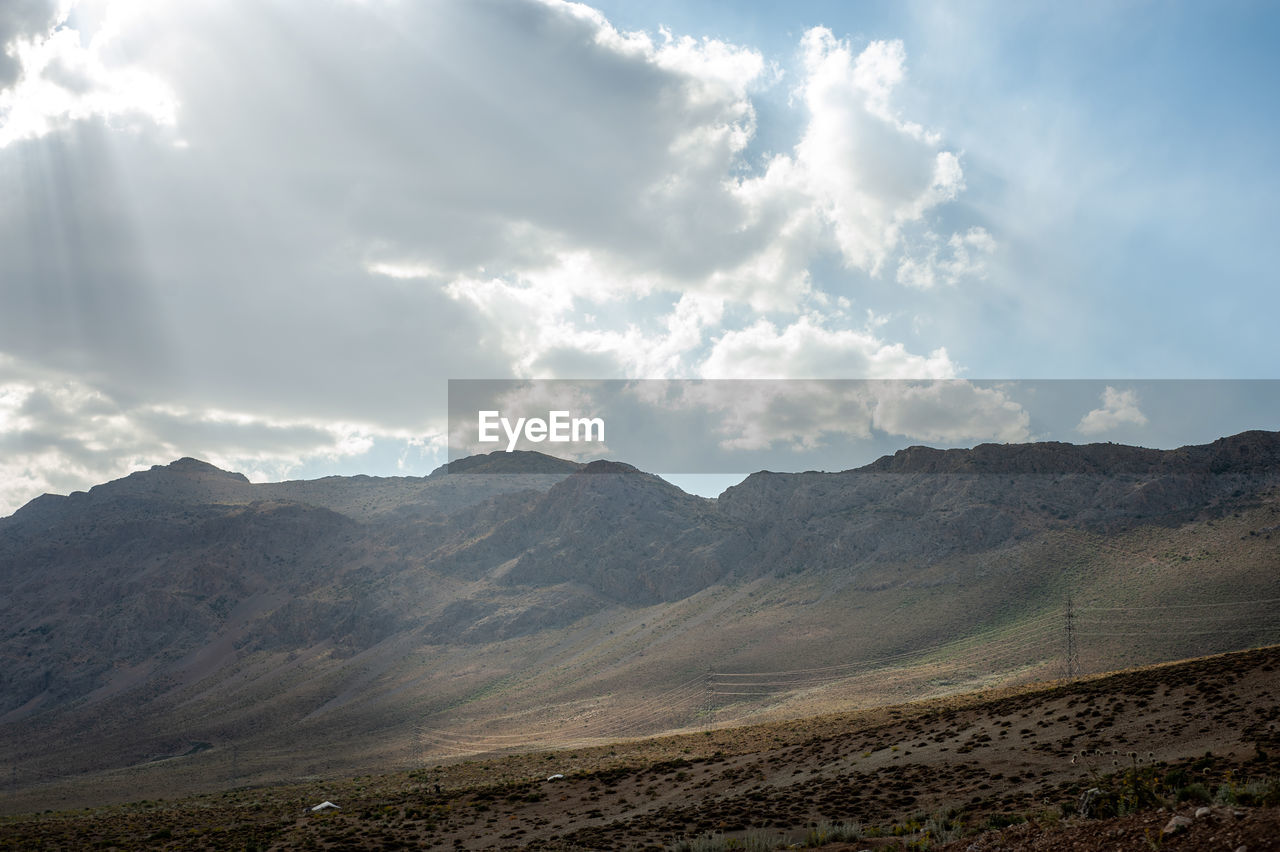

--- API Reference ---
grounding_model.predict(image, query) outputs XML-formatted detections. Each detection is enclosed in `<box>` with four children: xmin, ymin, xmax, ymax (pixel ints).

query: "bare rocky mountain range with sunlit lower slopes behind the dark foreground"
<box><xmin>0</xmin><ymin>432</ymin><xmax>1280</xmax><ymax>810</ymax></box>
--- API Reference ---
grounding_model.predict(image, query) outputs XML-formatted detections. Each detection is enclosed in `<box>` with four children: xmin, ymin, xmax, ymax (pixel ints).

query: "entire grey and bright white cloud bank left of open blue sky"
<box><xmin>0</xmin><ymin>0</ymin><xmax>984</xmax><ymax>499</ymax></box>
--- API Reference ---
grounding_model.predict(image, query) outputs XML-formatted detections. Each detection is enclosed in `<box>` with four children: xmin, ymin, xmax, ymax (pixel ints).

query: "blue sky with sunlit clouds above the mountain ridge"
<box><xmin>0</xmin><ymin>0</ymin><xmax>1280</xmax><ymax>513</ymax></box>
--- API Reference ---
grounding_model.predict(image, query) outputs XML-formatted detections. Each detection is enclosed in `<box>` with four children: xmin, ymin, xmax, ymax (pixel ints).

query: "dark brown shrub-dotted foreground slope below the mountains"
<box><xmin>0</xmin><ymin>647</ymin><xmax>1280</xmax><ymax>852</ymax></box>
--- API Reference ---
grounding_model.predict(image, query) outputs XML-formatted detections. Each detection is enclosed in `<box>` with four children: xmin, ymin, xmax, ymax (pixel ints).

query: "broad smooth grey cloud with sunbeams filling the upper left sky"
<box><xmin>0</xmin><ymin>3</ymin><xmax>757</xmax><ymax>425</ymax></box>
